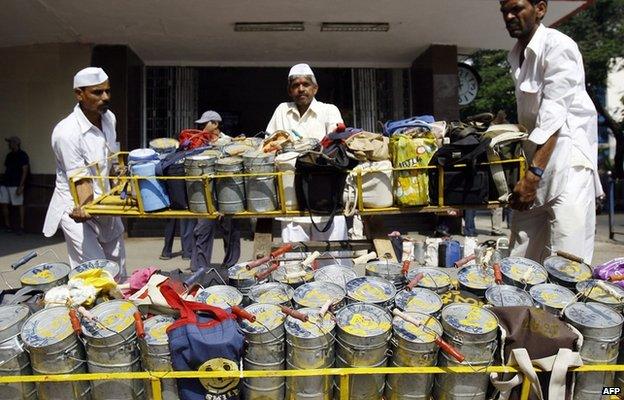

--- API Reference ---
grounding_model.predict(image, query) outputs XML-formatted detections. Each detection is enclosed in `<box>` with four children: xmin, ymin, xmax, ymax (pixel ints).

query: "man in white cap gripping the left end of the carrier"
<box><xmin>43</xmin><ymin>67</ymin><xmax>125</xmax><ymax>279</ymax></box>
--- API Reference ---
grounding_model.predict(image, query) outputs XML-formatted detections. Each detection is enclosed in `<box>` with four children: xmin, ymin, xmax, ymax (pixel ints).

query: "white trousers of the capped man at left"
<box><xmin>61</xmin><ymin>213</ymin><xmax>127</xmax><ymax>276</ymax></box>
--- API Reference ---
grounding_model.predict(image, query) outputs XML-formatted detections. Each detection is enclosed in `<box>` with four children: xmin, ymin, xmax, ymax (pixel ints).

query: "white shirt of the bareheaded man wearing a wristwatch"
<box><xmin>508</xmin><ymin>24</ymin><xmax>602</xmax><ymax>206</ymax></box>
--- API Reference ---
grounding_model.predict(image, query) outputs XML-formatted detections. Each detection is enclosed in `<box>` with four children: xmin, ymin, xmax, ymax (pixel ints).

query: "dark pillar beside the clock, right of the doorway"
<box><xmin>411</xmin><ymin>44</ymin><xmax>459</xmax><ymax>121</ymax></box>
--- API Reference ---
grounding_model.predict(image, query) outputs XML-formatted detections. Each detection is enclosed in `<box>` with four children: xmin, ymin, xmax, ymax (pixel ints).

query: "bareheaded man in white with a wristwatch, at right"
<box><xmin>500</xmin><ymin>0</ymin><xmax>602</xmax><ymax>263</ymax></box>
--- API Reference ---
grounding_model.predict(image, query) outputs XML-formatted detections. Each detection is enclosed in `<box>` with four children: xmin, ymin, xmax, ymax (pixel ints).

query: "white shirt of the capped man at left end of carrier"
<box><xmin>43</xmin><ymin>105</ymin><xmax>123</xmax><ymax>239</ymax></box>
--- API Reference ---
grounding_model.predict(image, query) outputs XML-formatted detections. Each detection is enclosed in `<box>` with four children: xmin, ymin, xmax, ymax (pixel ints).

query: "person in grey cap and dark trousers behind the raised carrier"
<box><xmin>191</xmin><ymin>110</ymin><xmax>241</xmax><ymax>279</ymax></box>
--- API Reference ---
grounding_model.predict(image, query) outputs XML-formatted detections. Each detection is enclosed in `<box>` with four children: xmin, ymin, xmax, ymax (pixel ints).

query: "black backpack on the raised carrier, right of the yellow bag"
<box><xmin>429</xmin><ymin>135</ymin><xmax>491</xmax><ymax>205</ymax></box>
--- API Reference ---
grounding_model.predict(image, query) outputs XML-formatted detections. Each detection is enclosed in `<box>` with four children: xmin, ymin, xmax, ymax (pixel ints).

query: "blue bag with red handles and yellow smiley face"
<box><xmin>160</xmin><ymin>285</ymin><xmax>244</xmax><ymax>400</ymax></box>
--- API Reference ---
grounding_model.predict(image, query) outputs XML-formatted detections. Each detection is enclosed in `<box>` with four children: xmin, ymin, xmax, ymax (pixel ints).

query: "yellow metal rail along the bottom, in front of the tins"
<box><xmin>0</xmin><ymin>365</ymin><xmax>624</xmax><ymax>400</ymax></box>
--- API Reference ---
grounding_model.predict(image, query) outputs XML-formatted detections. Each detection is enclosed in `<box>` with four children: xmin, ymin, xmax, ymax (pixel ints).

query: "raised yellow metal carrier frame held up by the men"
<box><xmin>69</xmin><ymin>152</ymin><xmax>527</xmax><ymax>219</ymax></box>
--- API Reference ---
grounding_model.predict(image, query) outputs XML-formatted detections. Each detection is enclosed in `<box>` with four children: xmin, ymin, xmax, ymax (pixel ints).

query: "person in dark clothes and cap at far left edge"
<box><xmin>0</xmin><ymin>136</ymin><xmax>30</xmax><ymax>235</ymax></box>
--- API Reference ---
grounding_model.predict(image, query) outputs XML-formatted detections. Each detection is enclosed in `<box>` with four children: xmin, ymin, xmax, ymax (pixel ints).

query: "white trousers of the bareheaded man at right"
<box><xmin>510</xmin><ymin>167</ymin><xmax>596</xmax><ymax>264</ymax></box>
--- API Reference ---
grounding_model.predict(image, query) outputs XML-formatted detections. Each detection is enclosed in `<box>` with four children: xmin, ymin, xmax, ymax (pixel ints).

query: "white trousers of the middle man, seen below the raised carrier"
<box><xmin>282</xmin><ymin>215</ymin><xmax>353</xmax><ymax>265</ymax></box>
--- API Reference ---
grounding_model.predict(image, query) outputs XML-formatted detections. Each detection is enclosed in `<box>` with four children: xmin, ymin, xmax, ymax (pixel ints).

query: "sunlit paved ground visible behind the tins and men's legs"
<box><xmin>0</xmin><ymin>214</ymin><xmax>624</xmax><ymax>288</ymax></box>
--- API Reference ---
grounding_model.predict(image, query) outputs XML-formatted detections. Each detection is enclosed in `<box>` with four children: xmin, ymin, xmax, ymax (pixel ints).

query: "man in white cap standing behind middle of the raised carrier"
<box><xmin>266</xmin><ymin>64</ymin><xmax>348</xmax><ymax>243</ymax></box>
